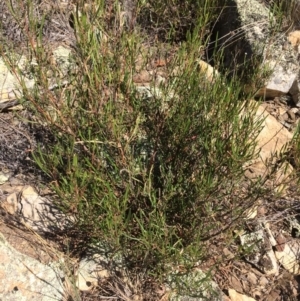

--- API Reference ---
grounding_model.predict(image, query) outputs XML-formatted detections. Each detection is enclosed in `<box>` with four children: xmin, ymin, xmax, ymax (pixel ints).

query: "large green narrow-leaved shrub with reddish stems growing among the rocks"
<box><xmin>2</xmin><ymin>0</ymin><xmax>299</xmax><ymax>294</ymax></box>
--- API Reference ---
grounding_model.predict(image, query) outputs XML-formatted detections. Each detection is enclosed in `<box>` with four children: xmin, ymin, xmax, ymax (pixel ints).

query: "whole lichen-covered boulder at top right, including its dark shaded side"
<box><xmin>211</xmin><ymin>0</ymin><xmax>300</xmax><ymax>104</ymax></box>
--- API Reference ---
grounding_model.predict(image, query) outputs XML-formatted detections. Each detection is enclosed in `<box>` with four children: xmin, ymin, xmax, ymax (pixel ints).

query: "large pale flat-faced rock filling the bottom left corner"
<box><xmin>0</xmin><ymin>233</ymin><xmax>64</xmax><ymax>301</ymax></box>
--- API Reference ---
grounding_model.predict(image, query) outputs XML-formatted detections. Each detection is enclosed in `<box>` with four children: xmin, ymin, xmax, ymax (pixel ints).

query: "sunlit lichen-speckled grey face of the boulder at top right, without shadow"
<box><xmin>240</xmin><ymin>0</ymin><xmax>299</xmax><ymax>103</ymax></box>
